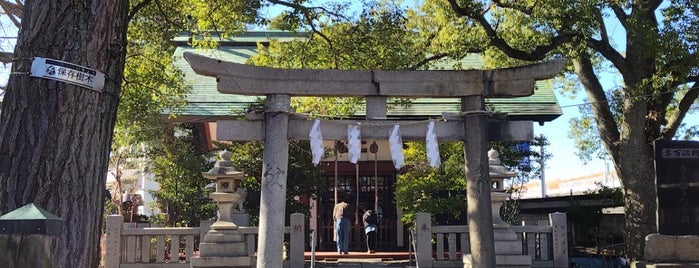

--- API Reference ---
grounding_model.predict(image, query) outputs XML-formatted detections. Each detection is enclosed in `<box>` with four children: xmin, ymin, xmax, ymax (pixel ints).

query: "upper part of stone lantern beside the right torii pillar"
<box><xmin>488</xmin><ymin>149</ymin><xmax>517</xmax><ymax>228</ymax></box>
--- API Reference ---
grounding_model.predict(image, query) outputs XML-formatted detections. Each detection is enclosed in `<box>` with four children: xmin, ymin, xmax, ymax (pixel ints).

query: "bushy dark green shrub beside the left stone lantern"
<box><xmin>151</xmin><ymin>125</ymin><xmax>217</xmax><ymax>226</ymax></box>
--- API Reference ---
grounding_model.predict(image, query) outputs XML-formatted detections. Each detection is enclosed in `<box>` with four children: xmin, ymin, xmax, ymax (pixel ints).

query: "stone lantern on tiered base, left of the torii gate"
<box><xmin>191</xmin><ymin>151</ymin><xmax>253</xmax><ymax>267</ymax></box>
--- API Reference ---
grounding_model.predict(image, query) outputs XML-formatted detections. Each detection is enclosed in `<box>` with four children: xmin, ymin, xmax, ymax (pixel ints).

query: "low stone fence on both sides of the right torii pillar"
<box><xmin>414</xmin><ymin>213</ymin><xmax>568</xmax><ymax>268</ymax></box>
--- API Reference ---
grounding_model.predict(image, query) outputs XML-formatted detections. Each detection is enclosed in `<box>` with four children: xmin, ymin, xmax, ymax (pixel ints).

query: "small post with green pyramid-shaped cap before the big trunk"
<box><xmin>0</xmin><ymin>204</ymin><xmax>63</xmax><ymax>268</ymax></box>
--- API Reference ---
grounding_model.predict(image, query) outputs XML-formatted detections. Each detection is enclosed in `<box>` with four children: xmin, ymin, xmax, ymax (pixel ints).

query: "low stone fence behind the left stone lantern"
<box><xmin>104</xmin><ymin>213</ymin><xmax>306</xmax><ymax>268</ymax></box>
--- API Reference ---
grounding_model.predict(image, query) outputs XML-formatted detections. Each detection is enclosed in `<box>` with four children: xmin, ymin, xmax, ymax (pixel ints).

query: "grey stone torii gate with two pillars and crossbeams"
<box><xmin>184</xmin><ymin>53</ymin><xmax>565</xmax><ymax>267</ymax></box>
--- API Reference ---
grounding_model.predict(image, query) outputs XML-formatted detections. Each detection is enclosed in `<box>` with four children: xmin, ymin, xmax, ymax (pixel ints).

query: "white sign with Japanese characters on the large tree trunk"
<box><xmin>29</xmin><ymin>57</ymin><xmax>104</xmax><ymax>92</ymax></box>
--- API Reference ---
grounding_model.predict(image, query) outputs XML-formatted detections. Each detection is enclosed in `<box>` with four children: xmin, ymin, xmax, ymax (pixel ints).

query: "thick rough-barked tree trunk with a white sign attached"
<box><xmin>0</xmin><ymin>0</ymin><xmax>128</xmax><ymax>267</ymax></box>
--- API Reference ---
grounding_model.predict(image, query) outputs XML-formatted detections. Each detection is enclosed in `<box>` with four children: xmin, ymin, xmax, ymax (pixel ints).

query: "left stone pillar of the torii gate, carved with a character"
<box><xmin>257</xmin><ymin>94</ymin><xmax>291</xmax><ymax>268</ymax></box>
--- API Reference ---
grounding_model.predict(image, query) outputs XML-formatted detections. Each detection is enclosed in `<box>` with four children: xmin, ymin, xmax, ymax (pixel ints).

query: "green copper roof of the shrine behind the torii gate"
<box><xmin>174</xmin><ymin>31</ymin><xmax>562</xmax><ymax>123</ymax></box>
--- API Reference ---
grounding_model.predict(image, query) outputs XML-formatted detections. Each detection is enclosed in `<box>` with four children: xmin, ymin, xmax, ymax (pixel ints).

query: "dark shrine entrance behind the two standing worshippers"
<box><xmin>318</xmin><ymin>161</ymin><xmax>403</xmax><ymax>252</ymax></box>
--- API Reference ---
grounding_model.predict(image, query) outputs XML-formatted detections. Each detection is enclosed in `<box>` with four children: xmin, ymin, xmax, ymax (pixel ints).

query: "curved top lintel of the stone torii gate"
<box><xmin>183</xmin><ymin>52</ymin><xmax>566</xmax><ymax>98</ymax></box>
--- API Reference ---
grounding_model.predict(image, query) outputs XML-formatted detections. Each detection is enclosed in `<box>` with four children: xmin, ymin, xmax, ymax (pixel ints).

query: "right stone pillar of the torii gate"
<box><xmin>461</xmin><ymin>96</ymin><xmax>495</xmax><ymax>267</ymax></box>
